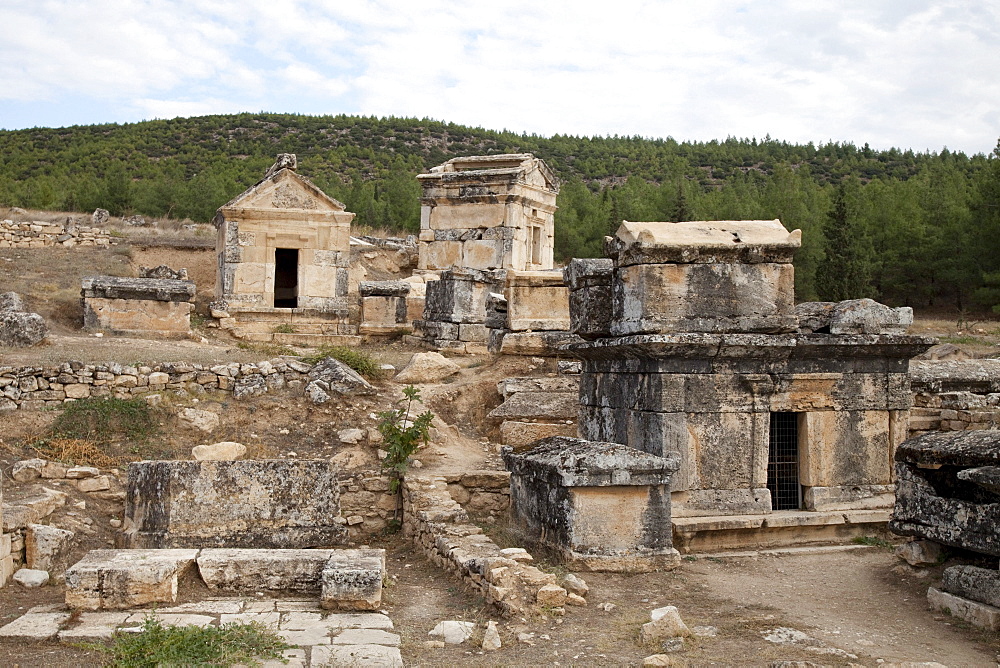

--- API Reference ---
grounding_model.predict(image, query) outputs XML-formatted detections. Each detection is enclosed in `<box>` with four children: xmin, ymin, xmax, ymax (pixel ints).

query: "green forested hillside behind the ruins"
<box><xmin>0</xmin><ymin>113</ymin><xmax>1000</xmax><ymax>310</ymax></box>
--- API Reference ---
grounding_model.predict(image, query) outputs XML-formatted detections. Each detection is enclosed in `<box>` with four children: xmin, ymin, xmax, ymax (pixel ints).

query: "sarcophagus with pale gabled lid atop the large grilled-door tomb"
<box><xmin>607</xmin><ymin>220</ymin><xmax>801</xmax><ymax>336</ymax></box>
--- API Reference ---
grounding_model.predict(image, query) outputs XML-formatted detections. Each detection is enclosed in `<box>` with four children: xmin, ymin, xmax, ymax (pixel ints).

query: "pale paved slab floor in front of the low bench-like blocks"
<box><xmin>0</xmin><ymin>598</ymin><xmax>403</xmax><ymax>668</ymax></box>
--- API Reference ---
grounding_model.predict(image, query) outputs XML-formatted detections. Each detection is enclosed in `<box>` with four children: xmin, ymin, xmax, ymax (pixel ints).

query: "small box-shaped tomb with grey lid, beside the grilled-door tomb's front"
<box><xmin>503</xmin><ymin>436</ymin><xmax>680</xmax><ymax>572</ymax></box>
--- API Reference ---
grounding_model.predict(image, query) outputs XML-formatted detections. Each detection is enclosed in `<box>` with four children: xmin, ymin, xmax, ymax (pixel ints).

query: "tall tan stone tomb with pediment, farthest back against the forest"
<box><xmin>417</xmin><ymin>153</ymin><xmax>559</xmax><ymax>271</ymax></box>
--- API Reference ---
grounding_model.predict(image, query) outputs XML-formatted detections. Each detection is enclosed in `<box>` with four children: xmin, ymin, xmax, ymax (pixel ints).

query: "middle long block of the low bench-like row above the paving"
<box><xmin>198</xmin><ymin>548</ymin><xmax>336</xmax><ymax>594</ymax></box>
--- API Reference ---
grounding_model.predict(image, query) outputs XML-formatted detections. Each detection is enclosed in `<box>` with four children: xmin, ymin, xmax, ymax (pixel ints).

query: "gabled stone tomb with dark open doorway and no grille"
<box><xmin>213</xmin><ymin>153</ymin><xmax>357</xmax><ymax>343</ymax></box>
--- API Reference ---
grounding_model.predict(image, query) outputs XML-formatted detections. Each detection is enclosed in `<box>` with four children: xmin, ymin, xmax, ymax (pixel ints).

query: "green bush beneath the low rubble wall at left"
<box><xmin>51</xmin><ymin>397</ymin><xmax>159</xmax><ymax>443</ymax></box>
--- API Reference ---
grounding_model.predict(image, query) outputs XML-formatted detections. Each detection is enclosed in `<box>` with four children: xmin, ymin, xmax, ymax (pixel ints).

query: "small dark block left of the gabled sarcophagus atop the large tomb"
<box><xmin>563</xmin><ymin>258</ymin><xmax>614</xmax><ymax>339</ymax></box>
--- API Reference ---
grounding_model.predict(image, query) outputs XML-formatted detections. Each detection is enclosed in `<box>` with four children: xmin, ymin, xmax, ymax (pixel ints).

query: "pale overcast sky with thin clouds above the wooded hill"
<box><xmin>0</xmin><ymin>0</ymin><xmax>1000</xmax><ymax>154</ymax></box>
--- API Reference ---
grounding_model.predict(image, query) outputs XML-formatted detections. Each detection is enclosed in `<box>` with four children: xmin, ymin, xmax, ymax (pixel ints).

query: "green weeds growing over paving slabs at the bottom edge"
<box><xmin>86</xmin><ymin>617</ymin><xmax>291</xmax><ymax>668</ymax></box>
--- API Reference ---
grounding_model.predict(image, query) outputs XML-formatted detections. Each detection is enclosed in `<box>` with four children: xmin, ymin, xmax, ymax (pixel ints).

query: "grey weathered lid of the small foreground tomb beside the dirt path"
<box><xmin>503</xmin><ymin>436</ymin><xmax>680</xmax><ymax>487</ymax></box>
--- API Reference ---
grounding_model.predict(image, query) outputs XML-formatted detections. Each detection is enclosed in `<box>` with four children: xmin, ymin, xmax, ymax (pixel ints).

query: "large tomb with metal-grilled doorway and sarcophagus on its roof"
<box><xmin>566</xmin><ymin>221</ymin><xmax>933</xmax><ymax>548</ymax></box>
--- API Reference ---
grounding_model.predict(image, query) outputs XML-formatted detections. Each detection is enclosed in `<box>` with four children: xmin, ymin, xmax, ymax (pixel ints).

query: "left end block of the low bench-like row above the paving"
<box><xmin>66</xmin><ymin>550</ymin><xmax>198</xmax><ymax>610</ymax></box>
